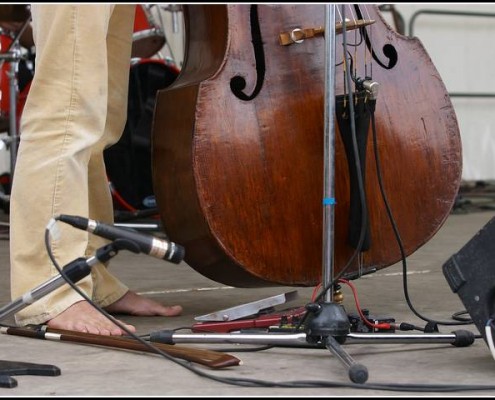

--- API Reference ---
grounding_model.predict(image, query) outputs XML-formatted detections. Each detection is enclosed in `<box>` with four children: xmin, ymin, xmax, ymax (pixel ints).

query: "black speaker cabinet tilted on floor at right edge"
<box><xmin>442</xmin><ymin>217</ymin><xmax>495</xmax><ymax>341</ymax></box>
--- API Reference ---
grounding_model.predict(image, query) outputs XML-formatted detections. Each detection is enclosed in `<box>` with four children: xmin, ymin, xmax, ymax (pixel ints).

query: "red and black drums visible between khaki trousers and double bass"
<box><xmin>104</xmin><ymin>4</ymin><xmax>179</xmax><ymax>221</ymax></box>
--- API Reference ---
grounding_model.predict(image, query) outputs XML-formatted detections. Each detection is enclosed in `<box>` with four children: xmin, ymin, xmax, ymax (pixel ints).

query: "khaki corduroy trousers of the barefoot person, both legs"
<box><xmin>10</xmin><ymin>3</ymin><xmax>135</xmax><ymax>325</ymax></box>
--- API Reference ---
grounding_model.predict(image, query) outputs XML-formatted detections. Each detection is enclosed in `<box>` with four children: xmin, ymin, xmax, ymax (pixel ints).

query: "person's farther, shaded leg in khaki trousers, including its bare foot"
<box><xmin>82</xmin><ymin>5</ymin><xmax>182</xmax><ymax>316</ymax></box>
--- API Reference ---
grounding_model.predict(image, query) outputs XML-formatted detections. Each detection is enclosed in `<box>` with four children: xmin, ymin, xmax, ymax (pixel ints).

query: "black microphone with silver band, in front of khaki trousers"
<box><xmin>56</xmin><ymin>215</ymin><xmax>185</xmax><ymax>264</ymax></box>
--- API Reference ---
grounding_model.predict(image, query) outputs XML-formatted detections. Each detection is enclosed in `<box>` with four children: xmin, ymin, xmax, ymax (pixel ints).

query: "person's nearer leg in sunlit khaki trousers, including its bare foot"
<box><xmin>10</xmin><ymin>4</ymin><xmax>133</xmax><ymax>334</ymax></box>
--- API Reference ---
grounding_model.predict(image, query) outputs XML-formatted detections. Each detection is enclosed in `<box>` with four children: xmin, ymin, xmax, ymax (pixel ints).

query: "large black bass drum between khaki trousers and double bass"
<box><xmin>104</xmin><ymin>59</ymin><xmax>179</xmax><ymax>211</ymax></box>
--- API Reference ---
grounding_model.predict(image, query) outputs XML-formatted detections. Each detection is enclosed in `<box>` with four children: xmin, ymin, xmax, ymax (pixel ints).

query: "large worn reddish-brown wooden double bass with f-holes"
<box><xmin>152</xmin><ymin>4</ymin><xmax>462</xmax><ymax>287</ymax></box>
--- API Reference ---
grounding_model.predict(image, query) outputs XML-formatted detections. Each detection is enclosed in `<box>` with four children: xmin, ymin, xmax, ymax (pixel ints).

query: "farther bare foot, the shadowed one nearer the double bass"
<box><xmin>105</xmin><ymin>290</ymin><xmax>182</xmax><ymax>317</ymax></box>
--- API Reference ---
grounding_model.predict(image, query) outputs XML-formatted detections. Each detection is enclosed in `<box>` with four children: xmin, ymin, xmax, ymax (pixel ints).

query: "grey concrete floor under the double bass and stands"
<box><xmin>0</xmin><ymin>210</ymin><xmax>495</xmax><ymax>397</ymax></box>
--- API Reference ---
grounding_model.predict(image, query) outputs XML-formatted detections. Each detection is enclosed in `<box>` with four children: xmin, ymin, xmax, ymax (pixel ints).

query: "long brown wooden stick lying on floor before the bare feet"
<box><xmin>0</xmin><ymin>327</ymin><xmax>241</xmax><ymax>369</ymax></box>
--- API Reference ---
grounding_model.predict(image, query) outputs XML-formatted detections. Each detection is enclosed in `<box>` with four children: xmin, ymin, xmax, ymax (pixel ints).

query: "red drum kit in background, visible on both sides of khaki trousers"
<box><xmin>0</xmin><ymin>4</ymin><xmax>184</xmax><ymax>213</ymax></box>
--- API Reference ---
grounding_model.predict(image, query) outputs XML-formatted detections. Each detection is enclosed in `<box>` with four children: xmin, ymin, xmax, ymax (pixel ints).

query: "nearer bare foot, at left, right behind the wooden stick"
<box><xmin>47</xmin><ymin>301</ymin><xmax>136</xmax><ymax>336</ymax></box>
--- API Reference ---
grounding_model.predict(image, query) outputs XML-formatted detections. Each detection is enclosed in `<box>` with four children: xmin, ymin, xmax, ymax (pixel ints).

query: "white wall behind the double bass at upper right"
<box><xmin>383</xmin><ymin>3</ymin><xmax>495</xmax><ymax>181</ymax></box>
